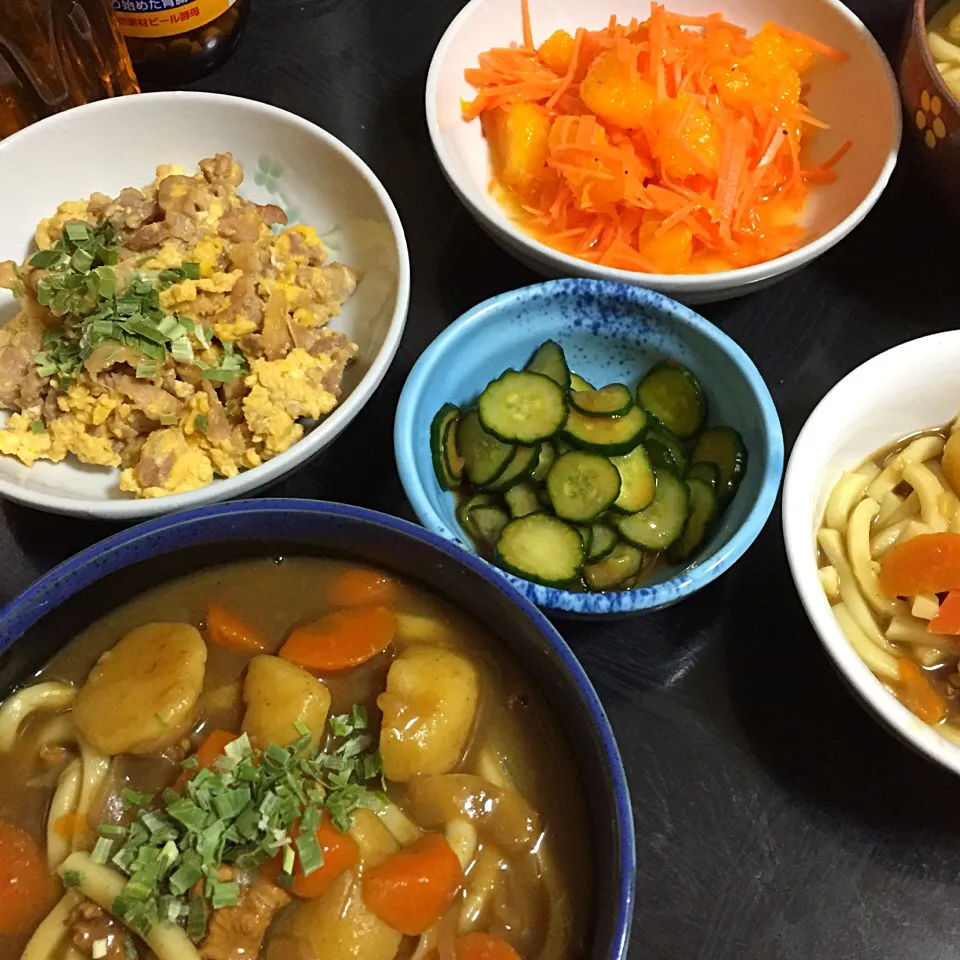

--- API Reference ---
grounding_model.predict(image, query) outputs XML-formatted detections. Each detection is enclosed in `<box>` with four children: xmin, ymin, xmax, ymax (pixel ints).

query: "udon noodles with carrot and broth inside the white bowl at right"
<box><xmin>817</xmin><ymin>419</ymin><xmax>960</xmax><ymax>744</ymax></box>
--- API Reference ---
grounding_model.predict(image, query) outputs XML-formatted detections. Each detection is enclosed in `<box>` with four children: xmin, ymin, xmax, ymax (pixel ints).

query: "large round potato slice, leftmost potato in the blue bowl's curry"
<box><xmin>73</xmin><ymin>623</ymin><xmax>207</xmax><ymax>754</ymax></box>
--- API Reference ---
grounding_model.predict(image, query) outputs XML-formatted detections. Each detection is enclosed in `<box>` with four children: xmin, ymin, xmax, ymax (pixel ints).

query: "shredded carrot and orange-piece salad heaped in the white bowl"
<box><xmin>462</xmin><ymin>0</ymin><xmax>851</xmax><ymax>273</ymax></box>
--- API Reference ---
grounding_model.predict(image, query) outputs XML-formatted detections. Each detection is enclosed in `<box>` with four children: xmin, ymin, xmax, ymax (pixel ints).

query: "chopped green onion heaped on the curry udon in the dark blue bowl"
<box><xmin>98</xmin><ymin>706</ymin><xmax>386</xmax><ymax>942</ymax></box>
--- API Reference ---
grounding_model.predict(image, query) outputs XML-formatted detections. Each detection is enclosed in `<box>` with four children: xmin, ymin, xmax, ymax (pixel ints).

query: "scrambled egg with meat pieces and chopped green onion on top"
<box><xmin>0</xmin><ymin>154</ymin><xmax>359</xmax><ymax>497</ymax></box>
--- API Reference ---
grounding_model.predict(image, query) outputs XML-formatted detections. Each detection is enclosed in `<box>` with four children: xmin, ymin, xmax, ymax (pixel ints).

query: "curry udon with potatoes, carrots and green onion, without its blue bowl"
<box><xmin>0</xmin><ymin>557</ymin><xmax>593</xmax><ymax>960</ymax></box>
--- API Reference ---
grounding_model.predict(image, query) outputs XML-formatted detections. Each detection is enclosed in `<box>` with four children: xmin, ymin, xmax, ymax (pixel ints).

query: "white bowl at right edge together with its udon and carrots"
<box><xmin>783</xmin><ymin>331</ymin><xmax>960</xmax><ymax>773</ymax></box>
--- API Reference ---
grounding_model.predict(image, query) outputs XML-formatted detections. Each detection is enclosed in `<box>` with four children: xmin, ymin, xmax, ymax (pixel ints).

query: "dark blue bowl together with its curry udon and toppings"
<box><xmin>0</xmin><ymin>500</ymin><xmax>635</xmax><ymax>960</ymax></box>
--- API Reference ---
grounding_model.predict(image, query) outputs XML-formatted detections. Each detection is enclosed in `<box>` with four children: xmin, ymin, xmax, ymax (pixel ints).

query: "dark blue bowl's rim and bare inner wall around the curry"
<box><xmin>0</xmin><ymin>500</ymin><xmax>636</xmax><ymax>960</ymax></box>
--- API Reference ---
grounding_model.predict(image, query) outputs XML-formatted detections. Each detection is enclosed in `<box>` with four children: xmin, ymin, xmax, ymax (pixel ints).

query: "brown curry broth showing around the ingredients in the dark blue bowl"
<box><xmin>0</xmin><ymin>557</ymin><xmax>593</xmax><ymax>960</ymax></box>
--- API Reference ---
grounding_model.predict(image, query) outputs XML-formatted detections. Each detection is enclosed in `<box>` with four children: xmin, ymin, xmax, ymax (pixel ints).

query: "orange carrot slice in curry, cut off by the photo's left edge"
<box><xmin>0</xmin><ymin>820</ymin><xmax>53</xmax><ymax>935</ymax></box>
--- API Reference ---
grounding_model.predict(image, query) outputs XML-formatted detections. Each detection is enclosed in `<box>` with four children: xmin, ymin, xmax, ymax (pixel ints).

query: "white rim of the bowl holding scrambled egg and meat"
<box><xmin>0</xmin><ymin>90</ymin><xmax>410</xmax><ymax>520</ymax></box>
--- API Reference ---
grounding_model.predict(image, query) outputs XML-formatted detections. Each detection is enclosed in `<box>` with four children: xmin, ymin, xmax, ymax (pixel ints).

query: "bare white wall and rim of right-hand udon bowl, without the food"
<box><xmin>783</xmin><ymin>331</ymin><xmax>960</xmax><ymax>774</ymax></box>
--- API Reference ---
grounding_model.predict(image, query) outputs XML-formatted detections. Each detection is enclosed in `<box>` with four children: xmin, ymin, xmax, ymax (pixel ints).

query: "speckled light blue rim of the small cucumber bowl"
<box><xmin>394</xmin><ymin>280</ymin><xmax>783</xmax><ymax>616</ymax></box>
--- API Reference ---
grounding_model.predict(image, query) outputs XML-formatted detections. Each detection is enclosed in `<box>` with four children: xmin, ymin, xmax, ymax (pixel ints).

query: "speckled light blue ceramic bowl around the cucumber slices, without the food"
<box><xmin>394</xmin><ymin>280</ymin><xmax>783</xmax><ymax>618</ymax></box>
